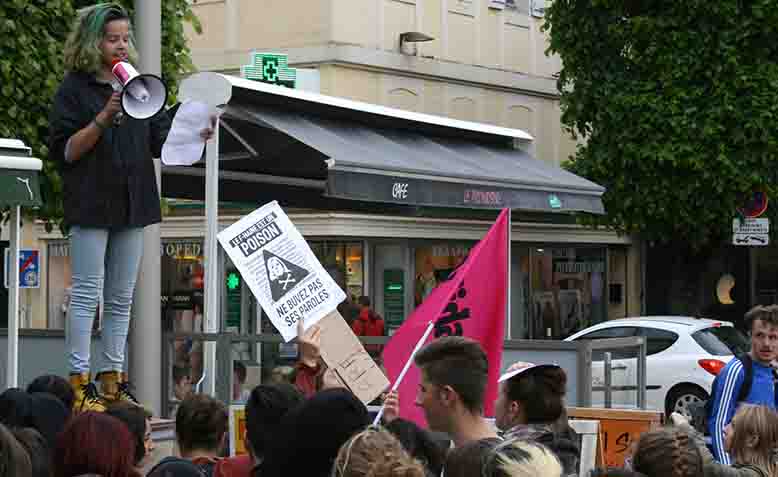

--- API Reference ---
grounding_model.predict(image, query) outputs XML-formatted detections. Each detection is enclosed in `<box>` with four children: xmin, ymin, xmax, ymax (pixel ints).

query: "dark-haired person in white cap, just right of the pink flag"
<box><xmin>494</xmin><ymin>363</ymin><xmax>581</xmax><ymax>476</ymax></box>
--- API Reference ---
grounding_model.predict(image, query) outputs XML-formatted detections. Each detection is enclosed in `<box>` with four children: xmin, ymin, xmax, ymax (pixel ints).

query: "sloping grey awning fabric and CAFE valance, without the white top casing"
<box><xmin>236</xmin><ymin>107</ymin><xmax>604</xmax><ymax>214</ymax></box>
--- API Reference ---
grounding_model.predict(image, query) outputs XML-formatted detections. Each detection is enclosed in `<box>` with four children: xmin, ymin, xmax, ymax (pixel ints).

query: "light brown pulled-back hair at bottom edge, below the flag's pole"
<box><xmin>332</xmin><ymin>427</ymin><xmax>425</xmax><ymax>477</ymax></box>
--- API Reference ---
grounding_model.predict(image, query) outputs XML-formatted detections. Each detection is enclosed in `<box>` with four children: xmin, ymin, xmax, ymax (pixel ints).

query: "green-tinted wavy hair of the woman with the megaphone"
<box><xmin>65</xmin><ymin>3</ymin><xmax>138</xmax><ymax>73</ymax></box>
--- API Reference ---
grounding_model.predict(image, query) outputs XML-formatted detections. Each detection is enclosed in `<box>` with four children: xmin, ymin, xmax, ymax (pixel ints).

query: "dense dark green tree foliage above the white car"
<box><xmin>544</xmin><ymin>0</ymin><xmax>778</xmax><ymax>250</ymax></box>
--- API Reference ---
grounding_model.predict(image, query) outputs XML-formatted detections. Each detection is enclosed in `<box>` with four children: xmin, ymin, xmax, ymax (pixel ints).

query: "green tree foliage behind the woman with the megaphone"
<box><xmin>0</xmin><ymin>0</ymin><xmax>200</xmax><ymax>231</ymax></box>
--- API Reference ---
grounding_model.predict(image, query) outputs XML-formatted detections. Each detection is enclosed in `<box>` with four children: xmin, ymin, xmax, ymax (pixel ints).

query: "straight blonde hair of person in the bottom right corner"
<box><xmin>729</xmin><ymin>404</ymin><xmax>778</xmax><ymax>477</ymax></box>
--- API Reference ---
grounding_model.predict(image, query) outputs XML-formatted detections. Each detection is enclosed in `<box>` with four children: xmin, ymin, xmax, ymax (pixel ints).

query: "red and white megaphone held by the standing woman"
<box><xmin>111</xmin><ymin>60</ymin><xmax>167</xmax><ymax>119</ymax></box>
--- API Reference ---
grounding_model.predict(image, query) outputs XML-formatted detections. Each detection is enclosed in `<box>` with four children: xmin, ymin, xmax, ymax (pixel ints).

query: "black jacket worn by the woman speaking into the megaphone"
<box><xmin>49</xmin><ymin>73</ymin><xmax>171</xmax><ymax>229</ymax></box>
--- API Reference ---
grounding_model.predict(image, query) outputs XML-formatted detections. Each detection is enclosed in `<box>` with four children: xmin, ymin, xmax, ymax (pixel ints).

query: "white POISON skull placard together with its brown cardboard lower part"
<box><xmin>218</xmin><ymin>201</ymin><xmax>389</xmax><ymax>404</ymax></box>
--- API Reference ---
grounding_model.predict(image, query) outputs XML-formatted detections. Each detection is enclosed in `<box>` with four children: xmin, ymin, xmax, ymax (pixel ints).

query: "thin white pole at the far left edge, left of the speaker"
<box><xmin>5</xmin><ymin>205</ymin><xmax>21</xmax><ymax>388</ymax></box>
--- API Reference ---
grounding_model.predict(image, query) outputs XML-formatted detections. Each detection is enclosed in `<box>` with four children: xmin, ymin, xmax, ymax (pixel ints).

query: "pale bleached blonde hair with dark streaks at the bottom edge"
<box><xmin>481</xmin><ymin>439</ymin><xmax>562</xmax><ymax>477</ymax></box>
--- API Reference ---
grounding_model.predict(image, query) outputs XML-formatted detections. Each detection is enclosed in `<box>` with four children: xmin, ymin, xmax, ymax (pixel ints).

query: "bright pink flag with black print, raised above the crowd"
<box><xmin>383</xmin><ymin>209</ymin><xmax>508</xmax><ymax>427</ymax></box>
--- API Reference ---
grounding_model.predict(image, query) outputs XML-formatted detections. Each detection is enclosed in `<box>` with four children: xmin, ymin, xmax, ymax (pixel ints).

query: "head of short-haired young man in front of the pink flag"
<box><xmin>414</xmin><ymin>336</ymin><xmax>489</xmax><ymax>433</ymax></box>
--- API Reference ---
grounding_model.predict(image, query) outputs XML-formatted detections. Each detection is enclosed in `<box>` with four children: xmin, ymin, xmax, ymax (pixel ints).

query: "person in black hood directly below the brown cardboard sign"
<box><xmin>259</xmin><ymin>388</ymin><xmax>370</xmax><ymax>477</ymax></box>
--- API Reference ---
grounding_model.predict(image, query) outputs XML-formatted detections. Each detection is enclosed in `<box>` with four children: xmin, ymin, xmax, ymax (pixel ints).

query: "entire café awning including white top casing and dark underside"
<box><xmin>163</xmin><ymin>77</ymin><xmax>604</xmax><ymax>214</ymax></box>
